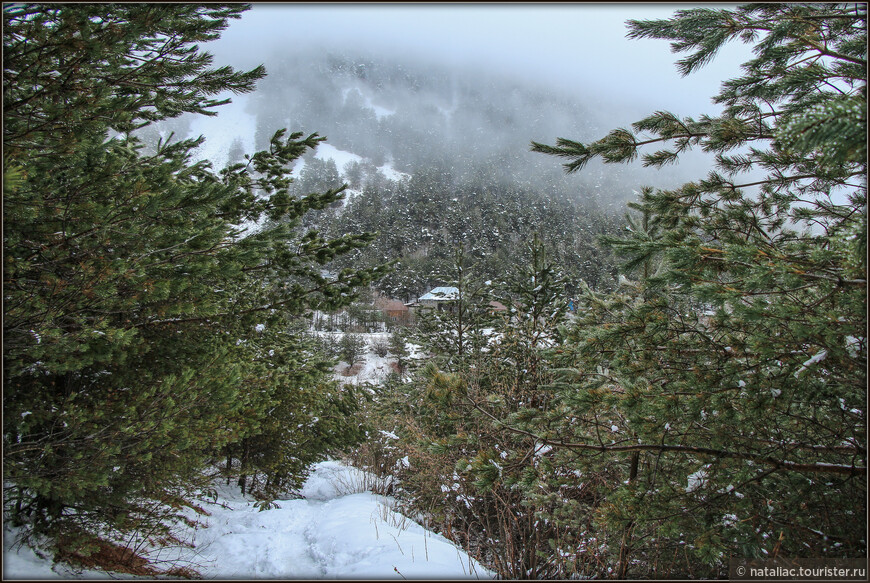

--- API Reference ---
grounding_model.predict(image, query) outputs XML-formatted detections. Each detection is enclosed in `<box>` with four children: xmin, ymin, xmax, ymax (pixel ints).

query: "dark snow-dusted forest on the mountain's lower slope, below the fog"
<box><xmin>298</xmin><ymin>161</ymin><xmax>621</xmax><ymax>301</ymax></box>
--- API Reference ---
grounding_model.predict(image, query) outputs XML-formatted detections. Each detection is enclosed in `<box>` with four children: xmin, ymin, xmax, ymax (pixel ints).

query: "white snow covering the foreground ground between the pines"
<box><xmin>3</xmin><ymin>461</ymin><xmax>494</xmax><ymax>579</ymax></box>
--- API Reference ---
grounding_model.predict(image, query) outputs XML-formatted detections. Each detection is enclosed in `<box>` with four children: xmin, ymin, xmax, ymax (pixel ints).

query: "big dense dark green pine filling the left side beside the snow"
<box><xmin>3</xmin><ymin>4</ymin><xmax>383</xmax><ymax>572</ymax></box>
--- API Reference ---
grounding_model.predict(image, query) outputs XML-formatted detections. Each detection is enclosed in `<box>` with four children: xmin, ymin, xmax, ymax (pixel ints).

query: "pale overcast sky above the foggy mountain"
<box><xmin>204</xmin><ymin>2</ymin><xmax>751</xmax><ymax>124</ymax></box>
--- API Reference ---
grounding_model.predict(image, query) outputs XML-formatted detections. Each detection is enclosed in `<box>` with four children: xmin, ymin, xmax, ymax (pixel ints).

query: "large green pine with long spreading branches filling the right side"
<box><xmin>533</xmin><ymin>4</ymin><xmax>867</xmax><ymax>576</ymax></box>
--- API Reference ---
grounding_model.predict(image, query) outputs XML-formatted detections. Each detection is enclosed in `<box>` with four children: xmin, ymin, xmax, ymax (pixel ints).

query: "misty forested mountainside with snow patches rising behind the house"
<box><xmin>142</xmin><ymin>46</ymin><xmax>712</xmax><ymax>301</ymax></box>
